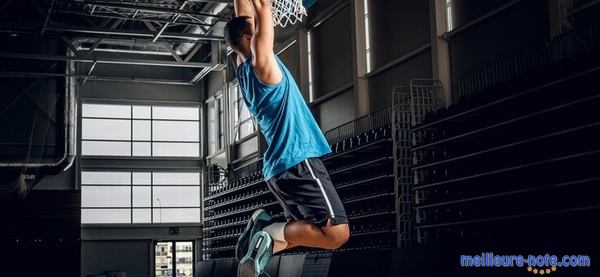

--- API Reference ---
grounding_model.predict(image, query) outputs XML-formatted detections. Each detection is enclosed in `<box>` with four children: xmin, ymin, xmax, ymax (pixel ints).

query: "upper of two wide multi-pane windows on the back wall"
<box><xmin>81</xmin><ymin>104</ymin><xmax>200</xmax><ymax>157</ymax></box>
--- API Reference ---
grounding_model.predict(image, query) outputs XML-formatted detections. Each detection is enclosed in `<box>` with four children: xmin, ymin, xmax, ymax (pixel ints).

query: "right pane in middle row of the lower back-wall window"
<box><xmin>153</xmin><ymin>186</ymin><xmax>200</xmax><ymax>207</ymax></box>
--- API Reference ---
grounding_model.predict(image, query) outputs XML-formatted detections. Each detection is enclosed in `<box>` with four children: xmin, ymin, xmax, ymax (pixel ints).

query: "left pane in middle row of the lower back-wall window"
<box><xmin>81</xmin><ymin>186</ymin><xmax>131</xmax><ymax>208</ymax></box>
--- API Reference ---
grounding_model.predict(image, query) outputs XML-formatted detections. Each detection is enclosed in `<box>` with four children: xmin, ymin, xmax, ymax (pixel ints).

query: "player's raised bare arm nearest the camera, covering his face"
<box><xmin>250</xmin><ymin>0</ymin><xmax>283</xmax><ymax>84</ymax></box>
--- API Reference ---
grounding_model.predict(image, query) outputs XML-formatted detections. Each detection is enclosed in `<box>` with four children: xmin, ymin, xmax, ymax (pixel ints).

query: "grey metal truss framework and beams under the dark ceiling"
<box><xmin>0</xmin><ymin>0</ymin><xmax>233</xmax><ymax>85</ymax></box>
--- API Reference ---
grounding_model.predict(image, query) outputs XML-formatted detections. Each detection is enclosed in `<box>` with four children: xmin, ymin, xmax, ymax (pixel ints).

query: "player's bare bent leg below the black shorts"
<box><xmin>274</xmin><ymin>219</ymin><xmax>350</xmax><ymax>252</ymax></box>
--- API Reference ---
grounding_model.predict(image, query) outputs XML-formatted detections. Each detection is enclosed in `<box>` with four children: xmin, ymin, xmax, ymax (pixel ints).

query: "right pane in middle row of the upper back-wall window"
<box><xmin>152</xmin><ymin>121</ymin><xmax>200</xmax><ymax>141</ymax></box>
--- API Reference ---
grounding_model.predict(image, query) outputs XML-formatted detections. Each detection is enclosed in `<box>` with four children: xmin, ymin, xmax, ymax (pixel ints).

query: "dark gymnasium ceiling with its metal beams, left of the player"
<box><xmin>0</xmin><ymin>0</ymin><xmax>233</xmax><ymax>84</ymax></box>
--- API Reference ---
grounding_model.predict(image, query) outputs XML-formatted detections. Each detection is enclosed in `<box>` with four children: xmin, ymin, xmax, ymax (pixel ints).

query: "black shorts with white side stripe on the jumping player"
<box><xmin>267</xmin><ymin>158</ymin><xmax>348</xmax><ymax>227</ymax></box>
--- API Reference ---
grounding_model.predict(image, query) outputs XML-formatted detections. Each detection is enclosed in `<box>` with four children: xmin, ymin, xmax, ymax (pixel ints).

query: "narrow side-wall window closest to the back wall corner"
<box><xmin>207</xmin><ymin>93</ymin><xmax>225</xmax><ymax>154</ymax></box>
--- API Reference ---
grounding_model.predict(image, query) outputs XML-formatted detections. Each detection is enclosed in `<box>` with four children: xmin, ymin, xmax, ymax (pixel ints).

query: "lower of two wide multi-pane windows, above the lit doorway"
<box><xmin>81</xmin><ymin>171</ymin><xmax>200</xmax><ymax>224</ymax></box>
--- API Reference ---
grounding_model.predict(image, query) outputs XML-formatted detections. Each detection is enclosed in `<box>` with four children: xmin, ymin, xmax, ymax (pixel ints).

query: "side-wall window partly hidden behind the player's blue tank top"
<box><xmin>229</xmin><ymin>84</ymin><xmax>256</xmax><ymax>142</ymax></box>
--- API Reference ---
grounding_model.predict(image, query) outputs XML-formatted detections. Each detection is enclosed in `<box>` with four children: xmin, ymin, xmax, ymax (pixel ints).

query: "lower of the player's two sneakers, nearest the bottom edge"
<box><xmin>237</xmin><ymin>231</ymin><xmax>273</xmax><ymax>277</ymax></box>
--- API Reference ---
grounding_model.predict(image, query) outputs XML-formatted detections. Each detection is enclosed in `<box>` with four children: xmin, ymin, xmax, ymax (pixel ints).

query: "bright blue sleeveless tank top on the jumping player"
<box><xmin>237</xmin><ymin>56</ymin><xmax>331</xmax><ymax>181</ymax></box>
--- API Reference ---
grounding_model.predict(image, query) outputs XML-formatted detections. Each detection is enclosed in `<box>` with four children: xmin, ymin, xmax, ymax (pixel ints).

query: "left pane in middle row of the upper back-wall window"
<box><xmin>81</xmin><ymin>118</ymin><xmax>131</xmax><ymax>140</ymax></box>
